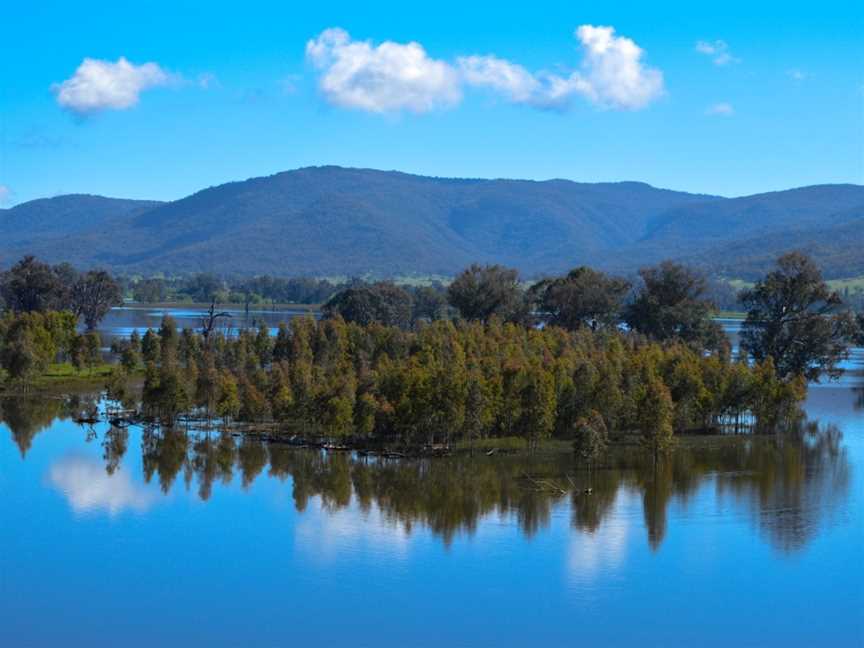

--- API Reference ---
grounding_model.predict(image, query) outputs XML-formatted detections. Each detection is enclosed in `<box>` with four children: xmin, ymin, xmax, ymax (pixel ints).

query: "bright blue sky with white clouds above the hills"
<box><xmin>0</xmin><ymin>0</ymin><xmax>864</xmax><ymax>206</ymax></box>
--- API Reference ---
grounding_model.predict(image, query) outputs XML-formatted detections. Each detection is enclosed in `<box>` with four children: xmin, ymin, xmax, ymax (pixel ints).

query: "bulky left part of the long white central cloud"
<box><xmin>306</xmin><ymin>28</ymin><xmax>462</xmax><ymax>113</ymax></box>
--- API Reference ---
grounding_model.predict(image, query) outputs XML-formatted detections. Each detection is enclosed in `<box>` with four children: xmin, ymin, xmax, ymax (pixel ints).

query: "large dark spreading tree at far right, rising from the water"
<box><xmin>741</xmin><ymin>252</ymin><xmax>856</xmax><ymax>381</ymax></box>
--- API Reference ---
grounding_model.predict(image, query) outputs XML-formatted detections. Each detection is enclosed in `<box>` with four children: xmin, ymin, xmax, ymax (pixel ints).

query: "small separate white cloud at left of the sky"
<box><xmin>51</xmin><ymin>56</ymin><xmax>172</xmax><ymax>115</ymax></box>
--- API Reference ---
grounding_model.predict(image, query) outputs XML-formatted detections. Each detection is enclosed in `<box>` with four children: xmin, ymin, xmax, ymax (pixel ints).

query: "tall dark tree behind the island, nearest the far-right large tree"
<box><xmin>624</xmin><ymin>261</ymin><xmax>725</xmax><ymax>349</ymax></box>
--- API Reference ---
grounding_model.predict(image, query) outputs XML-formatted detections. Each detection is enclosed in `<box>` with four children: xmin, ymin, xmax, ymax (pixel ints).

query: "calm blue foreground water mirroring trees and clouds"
<box><xmin>0</xmin><ymin>314</ymin><xmax>864</xmax><ymax>646</ymax></box>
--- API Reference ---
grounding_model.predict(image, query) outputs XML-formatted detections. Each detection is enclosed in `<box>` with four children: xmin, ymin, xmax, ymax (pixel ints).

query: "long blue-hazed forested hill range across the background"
<box><xmin>0</xmin><ymin>167</ymin><xmax>864</xmax><ymax>276</ymax></box>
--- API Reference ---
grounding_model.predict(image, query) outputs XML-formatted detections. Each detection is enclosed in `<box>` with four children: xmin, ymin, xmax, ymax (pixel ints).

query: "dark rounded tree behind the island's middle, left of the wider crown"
<box><xmin>447</xmin><ymin>264</ymin><xmax>526</xmax><ymax>322</ymax></box>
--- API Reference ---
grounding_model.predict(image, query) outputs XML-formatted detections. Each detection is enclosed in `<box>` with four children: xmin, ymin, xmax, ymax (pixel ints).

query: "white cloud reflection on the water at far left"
<box><xmin>48</xmin><ymin>456</ymin><xmax>155</xmax><ymax>516</ymax></box>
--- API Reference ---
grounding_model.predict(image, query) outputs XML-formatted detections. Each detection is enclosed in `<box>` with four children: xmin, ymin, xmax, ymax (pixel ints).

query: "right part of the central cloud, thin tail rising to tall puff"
<box><xmin>459</xmin><ymin>25</ymin><xmax>663</xmax><ymax>110</ymax></box>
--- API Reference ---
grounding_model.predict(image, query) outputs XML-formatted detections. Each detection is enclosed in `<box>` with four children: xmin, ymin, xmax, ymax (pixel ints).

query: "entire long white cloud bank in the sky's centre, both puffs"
<box><xmin>306</xmin><ymin>25</ymin><xmax>664</xmax><ymax>112</ymax></box>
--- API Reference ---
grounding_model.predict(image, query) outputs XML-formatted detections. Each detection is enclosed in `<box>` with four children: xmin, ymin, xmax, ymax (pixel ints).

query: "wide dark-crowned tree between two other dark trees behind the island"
<box><xmin>531</xmin><ymin>266</ymin><xmax>630</xmax><ymax>330</ymax></box>
